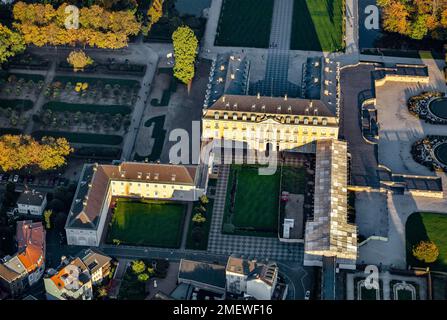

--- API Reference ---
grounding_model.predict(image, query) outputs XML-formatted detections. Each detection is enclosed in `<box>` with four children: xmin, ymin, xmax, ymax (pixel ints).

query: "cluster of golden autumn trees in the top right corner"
<box><xmin>378</xmin><ymin>0</ymin><xmax>447</xmax><ymax>40</ymax></box>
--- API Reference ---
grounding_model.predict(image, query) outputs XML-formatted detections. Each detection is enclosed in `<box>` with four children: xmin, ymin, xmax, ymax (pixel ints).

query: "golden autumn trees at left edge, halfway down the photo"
<box><xmin>0</xmin><ymin>135</ymin><xmax>73</xmax><ymax>171</ymax></box>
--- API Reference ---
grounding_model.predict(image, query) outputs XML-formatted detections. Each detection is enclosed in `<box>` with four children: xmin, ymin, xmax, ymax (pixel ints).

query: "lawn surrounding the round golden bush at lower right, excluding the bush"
<box><xmin>405</xmin><ymin>212</ymin><xmax>447</xmax><ymax>271</ymax></box>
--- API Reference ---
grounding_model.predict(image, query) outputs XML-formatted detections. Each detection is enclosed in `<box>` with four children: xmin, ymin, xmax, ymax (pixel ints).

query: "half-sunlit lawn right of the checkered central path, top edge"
<box><xmin>290</xmin><ymin>0</ymin><xmax>344</xmax><ymax>51</ymax></box>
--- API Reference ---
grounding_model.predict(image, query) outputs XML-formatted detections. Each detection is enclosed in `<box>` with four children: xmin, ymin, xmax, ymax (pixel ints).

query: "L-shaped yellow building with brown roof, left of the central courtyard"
<box><xmin>65</xmin><ymin>162</ymin><xmax>208</xmax><ymax>246</ymax></box>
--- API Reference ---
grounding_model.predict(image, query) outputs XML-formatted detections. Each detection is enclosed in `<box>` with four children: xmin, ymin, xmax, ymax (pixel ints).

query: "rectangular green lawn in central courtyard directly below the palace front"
<box><xmin>224</xmin><ymin>165</ymin><xmax>280</xmax><ymax>237</ymax></box>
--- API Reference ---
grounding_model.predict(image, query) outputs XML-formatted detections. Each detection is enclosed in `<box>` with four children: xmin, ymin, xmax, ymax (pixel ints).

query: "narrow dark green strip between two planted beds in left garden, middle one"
<box><xmin>43</xmin><ymin>101</ymin><xmax>131</xmax><ymax>114</ymax></box>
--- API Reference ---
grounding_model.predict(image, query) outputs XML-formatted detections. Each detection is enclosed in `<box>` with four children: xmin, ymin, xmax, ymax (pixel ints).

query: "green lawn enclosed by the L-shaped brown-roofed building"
<box><xmin>107</xmin><ymin>199</ymin><xmax>185</xmax><ymax>248</ymax></box>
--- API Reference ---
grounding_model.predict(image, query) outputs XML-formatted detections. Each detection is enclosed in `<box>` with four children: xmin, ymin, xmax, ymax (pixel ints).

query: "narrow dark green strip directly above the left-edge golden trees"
<box><xmin>32</xmin><ymin>130</ymin><xmax>123</xmax><ymax>145</ymax></box>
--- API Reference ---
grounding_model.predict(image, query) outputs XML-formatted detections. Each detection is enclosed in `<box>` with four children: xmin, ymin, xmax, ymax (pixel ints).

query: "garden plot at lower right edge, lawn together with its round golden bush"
<box><xmin>405</xmin><ymin>212</ymin><xmax>447</xmax><ymax>272</ymax></box>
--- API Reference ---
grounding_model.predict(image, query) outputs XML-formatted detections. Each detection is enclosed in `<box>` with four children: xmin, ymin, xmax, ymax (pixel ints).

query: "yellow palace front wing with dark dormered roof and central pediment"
<box><xmin>202</xmin><ymin>95</ymin><xmax>338</xmax><ymax>152</ymax></box>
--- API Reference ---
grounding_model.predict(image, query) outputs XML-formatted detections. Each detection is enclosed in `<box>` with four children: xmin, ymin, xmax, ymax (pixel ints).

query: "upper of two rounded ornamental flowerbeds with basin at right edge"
<box><xmin>407</xmin><ymin>91</ymin><xmax>447</xmax><ymax>124</ymax></box>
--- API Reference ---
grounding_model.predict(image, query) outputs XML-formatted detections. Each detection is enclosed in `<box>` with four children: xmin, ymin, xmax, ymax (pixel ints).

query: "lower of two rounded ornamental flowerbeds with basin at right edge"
<box><xmin>411</xmin><ymin>136</ymin><xmax>447</xmax><ymax>172</ymax></box>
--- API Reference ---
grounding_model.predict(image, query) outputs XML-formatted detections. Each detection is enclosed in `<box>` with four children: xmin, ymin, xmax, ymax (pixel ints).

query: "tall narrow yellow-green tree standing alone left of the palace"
<box><xmin>172</xmin><ymin>26</ymin><xmax>198</xmax><ymax>91</ymax></box>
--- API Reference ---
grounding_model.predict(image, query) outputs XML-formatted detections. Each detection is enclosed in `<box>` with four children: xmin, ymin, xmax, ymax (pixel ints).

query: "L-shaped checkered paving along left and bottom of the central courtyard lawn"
<box><xmin>208</xmin><ymin>165</ymin><xmax>303</xmax><ymax>263</ymax></box>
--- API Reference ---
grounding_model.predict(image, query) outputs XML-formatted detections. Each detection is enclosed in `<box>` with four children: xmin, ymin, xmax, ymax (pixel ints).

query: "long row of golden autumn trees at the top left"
<box><xmin>13</xmin><ymin>2</ymin><xmax>141</xmax><ymax>49</ymax></box>
